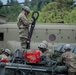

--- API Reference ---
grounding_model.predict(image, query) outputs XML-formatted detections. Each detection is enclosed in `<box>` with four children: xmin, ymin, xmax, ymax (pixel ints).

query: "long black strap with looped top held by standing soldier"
<box><xmin>26</xmin><ymin>11</ymin><xmax>39</xmax><ymax>49</ymax></box>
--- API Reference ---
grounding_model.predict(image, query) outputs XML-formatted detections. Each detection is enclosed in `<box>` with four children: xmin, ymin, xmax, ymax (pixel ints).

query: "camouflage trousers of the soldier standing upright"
<box><xmin>19</xmin><ymin>29</ymin><xmax>29</xmax><ymax>50</ymax></box>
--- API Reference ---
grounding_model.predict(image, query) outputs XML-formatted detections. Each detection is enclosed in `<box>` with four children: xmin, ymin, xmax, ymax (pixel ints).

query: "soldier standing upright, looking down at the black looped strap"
<box><xmin>17</xmin><ymin>6</ymin><xmax>32</xmax><ymax>50</ymax></box>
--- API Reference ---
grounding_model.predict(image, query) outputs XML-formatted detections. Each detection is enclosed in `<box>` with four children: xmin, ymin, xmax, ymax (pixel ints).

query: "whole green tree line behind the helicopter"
<box><xmin>0</xmin><ymin>0</ymin><xmax>76</xmax><ymax>24</ymax></box>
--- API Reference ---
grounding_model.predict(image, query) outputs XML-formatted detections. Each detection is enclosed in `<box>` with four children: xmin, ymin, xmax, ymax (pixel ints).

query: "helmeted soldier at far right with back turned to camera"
<box><xmin>60</xmin><ymin>44</ymin><xmax>76</xmax><ymax>75</ymax></box>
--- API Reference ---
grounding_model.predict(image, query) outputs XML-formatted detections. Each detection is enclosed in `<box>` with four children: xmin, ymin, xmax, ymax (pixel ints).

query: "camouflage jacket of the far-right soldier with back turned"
<box><xmin>60</xmin><ymin>52</ymin><xmax>76</xmax><ymax>72</ymax></box>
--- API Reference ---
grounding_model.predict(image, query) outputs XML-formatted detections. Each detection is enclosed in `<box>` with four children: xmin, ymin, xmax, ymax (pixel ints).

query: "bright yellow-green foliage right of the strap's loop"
<box><xmin>38</xmin><ymin>0</ymin><xmax>76</xmax><ymax>23</ymax></box>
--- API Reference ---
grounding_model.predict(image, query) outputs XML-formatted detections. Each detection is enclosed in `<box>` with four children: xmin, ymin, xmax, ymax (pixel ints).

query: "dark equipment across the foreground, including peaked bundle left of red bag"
<box><xmin>0</xmin><ymin>44</ymin><xmax>70</xmax><ymax>75</ymax></box>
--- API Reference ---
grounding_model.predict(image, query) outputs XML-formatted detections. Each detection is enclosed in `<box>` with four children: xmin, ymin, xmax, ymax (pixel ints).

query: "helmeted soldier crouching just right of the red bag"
<box><xmin>38</xmin><ymin>43</ymin><xmax>50</xmax><ymax>66</ymax></box>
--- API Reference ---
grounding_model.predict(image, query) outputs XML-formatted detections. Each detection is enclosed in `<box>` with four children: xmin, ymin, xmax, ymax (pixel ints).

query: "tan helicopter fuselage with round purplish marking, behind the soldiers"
<box><xmin>0</xmin><ymin>22</ymin><xmax>76</xmax><ymax>51</ymax></box>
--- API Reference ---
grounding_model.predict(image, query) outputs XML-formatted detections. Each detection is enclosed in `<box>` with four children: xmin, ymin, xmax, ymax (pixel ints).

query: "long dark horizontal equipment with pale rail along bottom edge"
<box><xmin>0</xmin><ymin>60</ymin><xmax>67</xmax><ymax>75</ymax></box>
